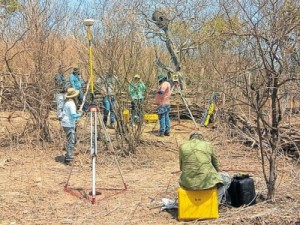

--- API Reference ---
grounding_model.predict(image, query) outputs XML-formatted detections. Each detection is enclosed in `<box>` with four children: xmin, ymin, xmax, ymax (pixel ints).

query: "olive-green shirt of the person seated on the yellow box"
<box><xmin>179</xmin><ymin>139</ymin><xmax>223</xmax><ymax>190</ymax></box>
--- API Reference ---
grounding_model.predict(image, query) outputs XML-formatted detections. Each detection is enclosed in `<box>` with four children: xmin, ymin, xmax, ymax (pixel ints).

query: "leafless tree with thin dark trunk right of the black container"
<box><xmin>224</xmin><ymin>0</ymin><xmax>300</xmax><ymax>199</ymax></box>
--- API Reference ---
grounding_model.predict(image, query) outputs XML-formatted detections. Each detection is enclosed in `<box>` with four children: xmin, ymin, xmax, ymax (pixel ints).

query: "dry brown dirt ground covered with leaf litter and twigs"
<box><xmin>0</xmin><ymin>113</ymin><xmax>300</xmax><ymax>225</ymax></box>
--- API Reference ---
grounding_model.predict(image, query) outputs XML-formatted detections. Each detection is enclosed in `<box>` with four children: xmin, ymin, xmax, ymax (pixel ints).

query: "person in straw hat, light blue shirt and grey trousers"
<box><xmin>61</xmin><ymin>88</ymin><xmax>81</xmax><ymax>164</ymax></box>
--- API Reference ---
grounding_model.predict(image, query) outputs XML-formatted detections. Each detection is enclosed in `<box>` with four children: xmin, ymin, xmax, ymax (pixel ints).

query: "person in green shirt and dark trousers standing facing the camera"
<box><xmin>128</xmin><ymin>74</ymin><xmax>146</xmax><ymax>124</ymax></box>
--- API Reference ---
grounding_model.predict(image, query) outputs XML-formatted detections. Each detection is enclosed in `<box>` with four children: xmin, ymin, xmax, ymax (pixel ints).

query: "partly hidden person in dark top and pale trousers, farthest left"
<box><xmin>55</xmin><ymin>66</ymin><xmax>68</xmax><ymax>120</ymax></box>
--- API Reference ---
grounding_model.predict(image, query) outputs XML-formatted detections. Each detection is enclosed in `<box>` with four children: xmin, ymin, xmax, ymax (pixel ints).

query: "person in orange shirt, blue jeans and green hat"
<box><xmin>155</xmin><ymin>74</ymin><xmax>171</xmax><ymax>137</ymax></box>
